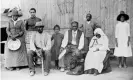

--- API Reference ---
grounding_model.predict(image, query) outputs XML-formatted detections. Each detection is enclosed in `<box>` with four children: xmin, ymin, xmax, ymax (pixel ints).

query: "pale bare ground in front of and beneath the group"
<box><xmin>0</xmin><ymin>54</ymin><xmax>133</xmax><ymax>80</ymax></box>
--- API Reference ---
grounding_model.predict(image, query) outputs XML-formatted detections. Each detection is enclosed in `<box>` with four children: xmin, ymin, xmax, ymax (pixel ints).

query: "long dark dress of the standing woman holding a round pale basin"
<box><xmin>4</xmin><ymin>20</ymin><xmax>28</xmax><ymax>67</ymax></box>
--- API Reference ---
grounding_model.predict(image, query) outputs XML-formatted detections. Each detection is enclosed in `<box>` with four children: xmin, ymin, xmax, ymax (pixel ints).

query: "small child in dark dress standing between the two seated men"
<box><xmin>51</xmin><ymin>25</ymin><xmax>64</xmax><ymax>69</ymax></box>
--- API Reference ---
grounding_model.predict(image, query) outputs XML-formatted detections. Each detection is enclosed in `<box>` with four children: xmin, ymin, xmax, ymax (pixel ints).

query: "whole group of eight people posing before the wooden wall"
<box><xmin>5</xmin><ymin>8</ymin><xmax>132</xmax><ymax>76</ymax></box>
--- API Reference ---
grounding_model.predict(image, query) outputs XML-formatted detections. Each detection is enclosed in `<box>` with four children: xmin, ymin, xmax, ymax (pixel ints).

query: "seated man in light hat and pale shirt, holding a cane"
<box><xmin>27</xmin><ymin>22</ymin><xmax>51</xmax><ymax>76</ymax></box>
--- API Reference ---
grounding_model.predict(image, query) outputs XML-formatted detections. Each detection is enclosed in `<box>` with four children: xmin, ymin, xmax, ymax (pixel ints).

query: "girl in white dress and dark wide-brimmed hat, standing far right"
<box><xmin>114</xmin><ymin>13</ymin><xmax>132</xmax><ymax>68</ymax></box>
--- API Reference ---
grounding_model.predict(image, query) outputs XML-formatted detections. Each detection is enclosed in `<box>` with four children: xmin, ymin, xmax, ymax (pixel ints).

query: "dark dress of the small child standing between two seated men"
<box><xmin>51</xmin><ymin>33</ymin><xmax>64</xmax><ymax>60</ymax></box>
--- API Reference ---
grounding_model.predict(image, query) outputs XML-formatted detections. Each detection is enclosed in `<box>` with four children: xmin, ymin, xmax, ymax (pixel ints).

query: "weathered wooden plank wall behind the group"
<box><xmin>21</xmin><ymin>0</ymin><xmax>133</xmax><ymax>47</ymax></box>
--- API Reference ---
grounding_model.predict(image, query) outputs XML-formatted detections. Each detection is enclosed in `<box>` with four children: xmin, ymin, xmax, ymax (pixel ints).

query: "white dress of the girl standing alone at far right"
<box><xmin>114</xmin><ymin>22</ymin><xmax>132</xmax><ymax>57</ymax></box>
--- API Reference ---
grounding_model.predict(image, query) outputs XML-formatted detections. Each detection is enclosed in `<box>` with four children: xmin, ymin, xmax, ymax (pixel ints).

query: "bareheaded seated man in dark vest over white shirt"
<box><xmin>60</xmin><ymin>21</ymin><xmax>84</xmax><ymax>71</ymax></box>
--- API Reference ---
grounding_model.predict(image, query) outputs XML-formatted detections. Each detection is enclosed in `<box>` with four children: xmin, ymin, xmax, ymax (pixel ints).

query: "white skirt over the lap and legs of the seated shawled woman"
<box><xmin>84</xmin><ymin>51</ymin><xmax>106</xmax><ymax>73</ymax></box>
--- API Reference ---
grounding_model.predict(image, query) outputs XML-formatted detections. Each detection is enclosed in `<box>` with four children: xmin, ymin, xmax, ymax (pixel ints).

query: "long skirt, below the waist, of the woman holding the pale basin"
<box><xmin>4</xmin><ymin>35</ymin><xmax>28</xmax><ymax>67</ymax></box>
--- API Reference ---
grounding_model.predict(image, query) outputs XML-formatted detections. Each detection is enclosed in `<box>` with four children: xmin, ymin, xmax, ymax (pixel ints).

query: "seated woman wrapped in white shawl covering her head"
<box><xmin>84</xmin><ymin>28</ymin><xmax>109</xmax><ymax>75</ymax></box>
